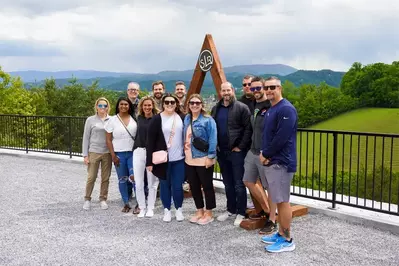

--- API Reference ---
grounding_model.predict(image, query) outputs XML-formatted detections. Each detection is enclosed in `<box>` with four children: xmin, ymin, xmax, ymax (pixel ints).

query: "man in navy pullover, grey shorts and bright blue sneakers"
<box><xmin>259</xmin><ymin>77</ymin><xmax>298</xmax><ymax>252</ymax></box>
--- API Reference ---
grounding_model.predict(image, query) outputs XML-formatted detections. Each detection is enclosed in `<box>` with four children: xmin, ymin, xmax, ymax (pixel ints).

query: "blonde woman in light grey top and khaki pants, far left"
<box><xmin>82</xmin><ymin>97</ymin><xmax>112</xmax><ymax>210</ymax></box>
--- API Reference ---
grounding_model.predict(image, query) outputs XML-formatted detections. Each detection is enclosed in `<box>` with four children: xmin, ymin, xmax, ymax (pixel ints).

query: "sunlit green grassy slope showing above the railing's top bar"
<box><xmin>310</xmin><ymin>108</ymin><xmax>399</xmax><ymax>134</ymax></box>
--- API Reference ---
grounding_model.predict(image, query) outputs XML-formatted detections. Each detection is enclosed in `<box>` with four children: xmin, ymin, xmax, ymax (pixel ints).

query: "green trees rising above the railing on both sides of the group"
<box><xmin>0</xmin><ymin>62</ymin><xmax>399</xmax><ymax>128</ymax></box>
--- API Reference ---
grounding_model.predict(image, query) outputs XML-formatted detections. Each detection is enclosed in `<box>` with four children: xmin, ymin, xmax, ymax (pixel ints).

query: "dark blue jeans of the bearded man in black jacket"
<box><xmin>218</xmin><ymin>151</ymin><xmax>247</xmax><ymax>216</ymax></box>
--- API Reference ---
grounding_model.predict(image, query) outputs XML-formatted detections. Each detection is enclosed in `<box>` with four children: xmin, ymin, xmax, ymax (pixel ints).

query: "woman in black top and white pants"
<box><xmin>133</xmin><ymin>96</ymin><xmax>159</xmax><ymax>218</ymax></box>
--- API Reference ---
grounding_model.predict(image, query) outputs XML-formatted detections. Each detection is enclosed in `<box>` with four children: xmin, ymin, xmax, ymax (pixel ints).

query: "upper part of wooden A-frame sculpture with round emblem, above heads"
<box><xmin>185</xmin><ymin>34</ymin><xmax>227</xmax><ymax>105</ymax></box>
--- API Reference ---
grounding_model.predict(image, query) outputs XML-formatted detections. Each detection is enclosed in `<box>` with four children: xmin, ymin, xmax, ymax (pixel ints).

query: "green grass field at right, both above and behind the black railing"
<box><xmin>294</xmin><ymin>108</ymin><xmax>399</xmax><ymax>204</ymax></box>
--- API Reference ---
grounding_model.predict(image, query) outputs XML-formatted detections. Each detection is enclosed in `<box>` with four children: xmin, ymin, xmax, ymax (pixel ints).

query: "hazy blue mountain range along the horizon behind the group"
<box><xmin>10</xmin><ymin>64</ymin><xmax>345</xmax><ymax>94</ymax></box>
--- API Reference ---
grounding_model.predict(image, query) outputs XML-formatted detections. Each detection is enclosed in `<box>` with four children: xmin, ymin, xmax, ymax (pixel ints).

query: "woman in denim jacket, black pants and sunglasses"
<box><xmin>184</xmin><ymin>94</ymin><xmax>217</xmax><ymax>225</ymax></box>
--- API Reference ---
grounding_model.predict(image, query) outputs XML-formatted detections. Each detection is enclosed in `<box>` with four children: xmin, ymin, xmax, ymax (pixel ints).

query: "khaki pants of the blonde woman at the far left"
<box><xmin>85</xmin><ymin>152</ymin><xmax>112</xmax><ymax>201</ymax></box>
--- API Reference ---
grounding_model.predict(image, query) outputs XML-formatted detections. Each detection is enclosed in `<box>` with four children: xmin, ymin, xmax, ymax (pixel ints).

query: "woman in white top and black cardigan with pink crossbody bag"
<box><xmin>146</xmin><ymin>93</ymin><xmax>184</xmax><ymax>222</ymax></box>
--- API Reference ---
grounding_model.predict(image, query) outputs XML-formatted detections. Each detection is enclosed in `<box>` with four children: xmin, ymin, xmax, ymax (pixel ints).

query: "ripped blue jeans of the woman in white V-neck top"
<box><xmin>115</xmin><ymin>151</ymin><xmax>136</xmax><ymax>204</ymax></box>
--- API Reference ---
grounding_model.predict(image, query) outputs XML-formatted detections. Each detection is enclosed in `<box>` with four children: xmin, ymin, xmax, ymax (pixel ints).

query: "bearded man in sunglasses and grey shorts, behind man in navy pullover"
<box><xmin>243</xmin><ymin>77</ymin><xmax>276</xmax><ymax>234</ymax></box>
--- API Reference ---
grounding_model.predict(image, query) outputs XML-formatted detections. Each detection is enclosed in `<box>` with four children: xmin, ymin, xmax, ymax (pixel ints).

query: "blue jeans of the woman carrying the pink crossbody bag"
<box><xmin>159</xmin><ymin>159</ymin><xmax>185</xmax><ymax>210</ymax></box>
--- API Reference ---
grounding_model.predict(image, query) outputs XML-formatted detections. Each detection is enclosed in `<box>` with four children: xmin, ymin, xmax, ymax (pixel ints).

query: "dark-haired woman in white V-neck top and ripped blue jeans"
<box><xmin>104</xmin><ymin>97</ymin><xmax>137</xmax><ymax>212</ymax></box>
